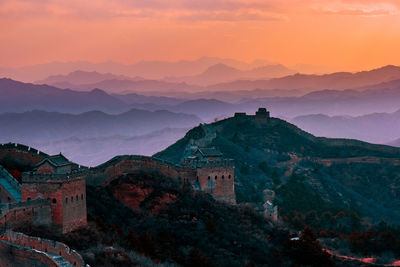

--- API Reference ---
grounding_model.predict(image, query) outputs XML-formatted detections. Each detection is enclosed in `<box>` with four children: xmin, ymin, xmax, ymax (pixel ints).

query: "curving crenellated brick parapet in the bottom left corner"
<box><xmin>3</xmin><ymin>230</ymin><xmax>85</xmax><ymax>267</ymax></box>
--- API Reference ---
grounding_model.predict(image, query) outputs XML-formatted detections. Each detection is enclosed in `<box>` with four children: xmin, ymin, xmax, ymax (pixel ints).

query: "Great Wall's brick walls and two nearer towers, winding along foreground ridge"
<box><xmin>0</xmin><ymin>140</ymin><xmax>235</xmax><ymax>267</ymax></box>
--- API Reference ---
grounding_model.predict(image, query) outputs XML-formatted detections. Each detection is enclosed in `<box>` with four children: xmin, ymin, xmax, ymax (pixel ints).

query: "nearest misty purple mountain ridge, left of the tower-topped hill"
<box><xmin>0</xmin><ymin>109</ymin><xmax>201</xmax><ymax>143</ymax></box>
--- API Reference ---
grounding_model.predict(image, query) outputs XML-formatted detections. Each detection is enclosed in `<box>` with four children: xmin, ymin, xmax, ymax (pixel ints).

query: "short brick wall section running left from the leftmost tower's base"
<box><xmin>0</xmin><ymin>199</ymin><xmax>51</xmax><ymax>230</ymax></box>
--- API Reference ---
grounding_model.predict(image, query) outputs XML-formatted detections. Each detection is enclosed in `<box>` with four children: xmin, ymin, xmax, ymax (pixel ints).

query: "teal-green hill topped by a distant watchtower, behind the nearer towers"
<box><xmin>156</xmin><ymin>111</ymin><xmax>400</xmax><ymax>226</ymax></box>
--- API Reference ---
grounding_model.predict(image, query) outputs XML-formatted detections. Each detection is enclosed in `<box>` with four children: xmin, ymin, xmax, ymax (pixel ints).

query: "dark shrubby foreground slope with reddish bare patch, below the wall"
<box><xmin>18</xmin><ymin>173</ymin><xmax>333</xmax><ymax>267</ymax></box>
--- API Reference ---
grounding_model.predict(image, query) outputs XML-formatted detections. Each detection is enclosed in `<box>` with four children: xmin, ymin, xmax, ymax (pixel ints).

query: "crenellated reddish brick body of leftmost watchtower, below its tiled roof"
<box><xmin>21</xmin><ymin>172</ymin><xmax>87</xmax><ymax>233</ymax></box>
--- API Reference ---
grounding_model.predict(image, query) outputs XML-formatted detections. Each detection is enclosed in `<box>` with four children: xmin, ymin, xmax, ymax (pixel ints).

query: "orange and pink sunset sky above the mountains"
<box><xmin>0</xmin><ymin>0</ymin><xmax>400</xmax><ymax>70</ymax></box>
